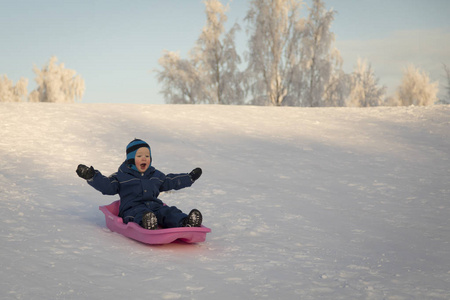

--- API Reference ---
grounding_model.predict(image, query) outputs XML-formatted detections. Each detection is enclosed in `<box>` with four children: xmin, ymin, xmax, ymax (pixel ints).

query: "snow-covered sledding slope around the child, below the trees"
<box><xmin>0</xmin><ymin>103</ymin><xmax>450</xmax><ymax>300</ymax></box>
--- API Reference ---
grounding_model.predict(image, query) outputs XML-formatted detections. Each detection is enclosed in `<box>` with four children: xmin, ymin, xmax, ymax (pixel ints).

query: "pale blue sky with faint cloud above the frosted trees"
<box><xmin>0</xmin><ymin>0</ymin><xmax>450</xmax><ymax>104</ymax></box>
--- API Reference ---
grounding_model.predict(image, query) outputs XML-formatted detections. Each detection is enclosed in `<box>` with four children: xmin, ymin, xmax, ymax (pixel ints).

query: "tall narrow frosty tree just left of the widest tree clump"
<box><xmin>192</xmin><ymin>0</ymin><xmax>244</xmax><ymax>104</ymax></box>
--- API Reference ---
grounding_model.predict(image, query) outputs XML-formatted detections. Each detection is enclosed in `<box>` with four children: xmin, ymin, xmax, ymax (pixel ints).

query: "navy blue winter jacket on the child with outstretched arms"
<box><xmin>87</xmin><ymin>162</ymin><xmax>192</xmax><ymax>216</ymax></box>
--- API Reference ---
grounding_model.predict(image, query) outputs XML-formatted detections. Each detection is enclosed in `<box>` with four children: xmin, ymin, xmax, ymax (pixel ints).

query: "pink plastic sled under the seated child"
<box><xmin>99</xmin><ymin>200</ymin><xmax>211</xmax><ymax>245</ymax></box>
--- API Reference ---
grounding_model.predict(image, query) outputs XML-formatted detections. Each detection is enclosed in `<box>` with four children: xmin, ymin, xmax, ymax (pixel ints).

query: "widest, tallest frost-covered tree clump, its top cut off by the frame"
<box><xmin>246</xmin><ymin>0</ymin><xmax>346</xmax><ymax>106</ymax></box>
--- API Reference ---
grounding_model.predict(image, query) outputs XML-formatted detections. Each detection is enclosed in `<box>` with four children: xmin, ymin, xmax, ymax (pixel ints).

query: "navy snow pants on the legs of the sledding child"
<box><xmin>122</xmin><ymin>201</ymin><xmax>187</xmax><ymax>228</ymax></box>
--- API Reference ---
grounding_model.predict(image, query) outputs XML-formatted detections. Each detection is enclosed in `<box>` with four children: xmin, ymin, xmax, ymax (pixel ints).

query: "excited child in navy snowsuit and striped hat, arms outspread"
<box><xmin>76</xmin><ymin>139</ymin><xmax>202</xmax><ymax>230</ymax></box>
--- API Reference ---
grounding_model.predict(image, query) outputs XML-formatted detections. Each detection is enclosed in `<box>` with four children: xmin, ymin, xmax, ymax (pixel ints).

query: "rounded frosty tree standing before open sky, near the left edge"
<box><xmin>29</xmin><ymin>56</ymin><xmax>85</xmax><ymax>102</ymax></box>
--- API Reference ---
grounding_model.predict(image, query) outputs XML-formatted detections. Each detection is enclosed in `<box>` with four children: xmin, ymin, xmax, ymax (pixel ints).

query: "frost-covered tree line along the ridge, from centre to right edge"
<box><xmin>156</xmin><ymin>0</ymin><xmax>450</xmax><ymax>107</ymax></box>
